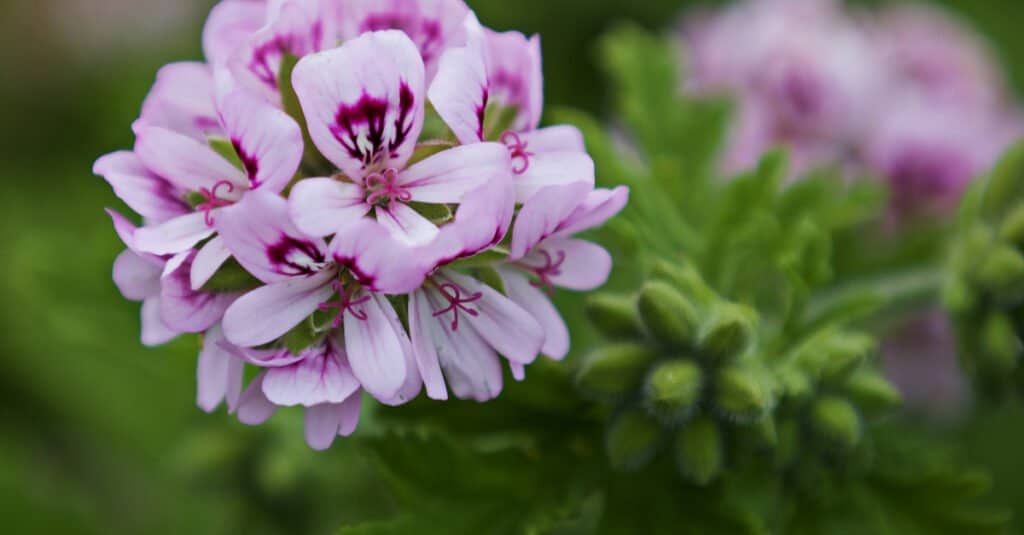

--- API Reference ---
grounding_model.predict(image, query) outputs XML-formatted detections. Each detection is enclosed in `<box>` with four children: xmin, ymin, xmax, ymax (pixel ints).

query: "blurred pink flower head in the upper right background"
<box><xmin>683</xmin><ymin>0</ymin><xmax>1024</xmax><ymax>216</ymax></box>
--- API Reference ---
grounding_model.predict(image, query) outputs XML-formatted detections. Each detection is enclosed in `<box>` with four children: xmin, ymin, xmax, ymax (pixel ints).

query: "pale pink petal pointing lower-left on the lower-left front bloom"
<box><xmin>223</xmin><ymin>270</ymin><xmax>336</xmax><ymax>347</ymax></box>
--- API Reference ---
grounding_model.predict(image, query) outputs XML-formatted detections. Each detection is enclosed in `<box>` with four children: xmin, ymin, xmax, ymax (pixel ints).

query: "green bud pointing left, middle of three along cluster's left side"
<box><xmin>575</xmin><ymin>343</ymin><xmax>656</xmax><ymax>397</ymax></box>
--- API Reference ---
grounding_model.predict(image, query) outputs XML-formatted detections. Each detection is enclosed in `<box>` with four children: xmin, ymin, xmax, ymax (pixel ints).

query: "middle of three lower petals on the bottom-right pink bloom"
<box><xmin>417</xmin><ymin>284</ymin><xmax>503</xmax><ymax>402</ymax></box>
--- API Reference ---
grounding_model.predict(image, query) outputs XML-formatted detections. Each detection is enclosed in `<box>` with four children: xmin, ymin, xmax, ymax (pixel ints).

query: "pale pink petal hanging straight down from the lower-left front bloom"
<box><xmin>345</xmin><ymin>292</ymin><xmax>413</xmax><ymax>400</ymax></box>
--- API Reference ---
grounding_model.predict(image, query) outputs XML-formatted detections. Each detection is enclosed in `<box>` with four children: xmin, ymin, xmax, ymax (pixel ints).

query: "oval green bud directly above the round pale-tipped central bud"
<box><xmin>638</xmin><ymin>281</ymin><xmax>697</xmax><ymax>347</ymax></box>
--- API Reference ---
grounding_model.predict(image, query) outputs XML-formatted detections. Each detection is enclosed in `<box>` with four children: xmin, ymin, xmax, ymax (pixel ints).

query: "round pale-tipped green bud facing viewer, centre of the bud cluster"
<box><xmin>644</xmin><ymin>359</ymin><xmax>703</xmax><ymax>422</ymax></box>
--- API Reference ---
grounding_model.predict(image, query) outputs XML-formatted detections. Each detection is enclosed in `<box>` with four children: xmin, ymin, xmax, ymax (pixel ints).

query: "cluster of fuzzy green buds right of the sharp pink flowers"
<box><xmin>575</xmin><ymin>258</ymin><xmax>901</xmax><ymax>485</ymax></box>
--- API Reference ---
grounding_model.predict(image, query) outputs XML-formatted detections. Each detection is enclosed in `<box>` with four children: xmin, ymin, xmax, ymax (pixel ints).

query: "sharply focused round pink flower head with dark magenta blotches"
<box><xmin>95</xmin><ymin>0</ymin><xmax>628</xmax><ymax>449</ymax></box>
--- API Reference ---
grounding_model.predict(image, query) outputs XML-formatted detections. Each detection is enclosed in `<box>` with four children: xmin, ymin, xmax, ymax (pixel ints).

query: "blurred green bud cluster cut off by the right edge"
<box><xmin>943</xmin><ymin>140</ymin><xmax>1024</xmax><ymax>398</ymax></box>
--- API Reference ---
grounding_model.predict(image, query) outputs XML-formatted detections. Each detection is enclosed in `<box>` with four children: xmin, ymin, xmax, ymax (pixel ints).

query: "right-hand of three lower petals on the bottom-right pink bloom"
<box><xmin>443</xmin><ymin>272</ymin><xmax>544</xmax><ymax>364</ymax></box>
